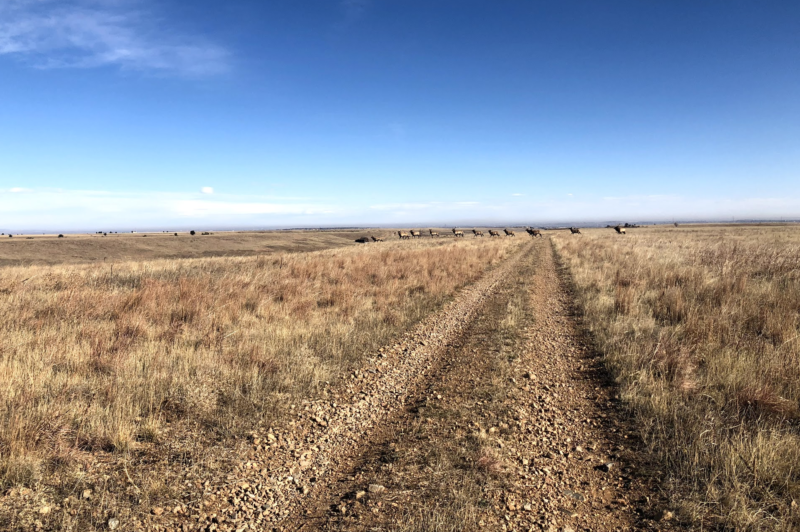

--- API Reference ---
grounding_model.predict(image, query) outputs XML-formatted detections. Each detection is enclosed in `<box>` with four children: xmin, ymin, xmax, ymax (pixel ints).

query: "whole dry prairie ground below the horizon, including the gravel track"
<box><xmin>0</xmin><ymin>225</ymin><xmax>800</xmax><ymax>532</ymax></box>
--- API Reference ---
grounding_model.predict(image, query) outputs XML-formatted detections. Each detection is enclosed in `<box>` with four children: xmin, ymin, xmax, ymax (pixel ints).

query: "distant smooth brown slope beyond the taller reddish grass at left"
<box><xmin>0</xmin><ymin>230</ymin><xmax>396</xmax><ymax>266</ymax></box>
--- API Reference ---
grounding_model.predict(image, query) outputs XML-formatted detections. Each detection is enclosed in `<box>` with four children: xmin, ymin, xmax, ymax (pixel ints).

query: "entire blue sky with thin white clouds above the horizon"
<box><xmin>0</xmin><ymin>0</ymin><xmax>800</xmax><ymax>232</ymax></box>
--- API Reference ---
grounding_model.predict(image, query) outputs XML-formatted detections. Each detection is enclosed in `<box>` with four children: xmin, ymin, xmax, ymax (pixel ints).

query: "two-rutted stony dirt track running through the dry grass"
<box><xmin>170</xmin><ymin>240</ymin><xmax>672</xmax><ymax>532</ymax></box>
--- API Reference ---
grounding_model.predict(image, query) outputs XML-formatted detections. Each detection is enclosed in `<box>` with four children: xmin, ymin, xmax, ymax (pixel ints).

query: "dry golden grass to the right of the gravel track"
<box><xmin>553</xmin><ymin>226</ymin><xmax>800</xmax><ymax>530</ymax></box>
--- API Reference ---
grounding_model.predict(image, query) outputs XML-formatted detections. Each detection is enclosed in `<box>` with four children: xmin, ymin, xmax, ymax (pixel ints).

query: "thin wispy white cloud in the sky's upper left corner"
<box><xmin>0</xmin><ymin>0</ymin><xmax>229</xmax><ymax>76</ymax></box>
